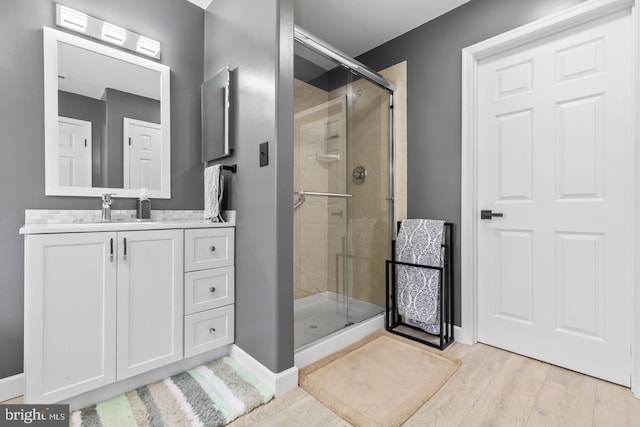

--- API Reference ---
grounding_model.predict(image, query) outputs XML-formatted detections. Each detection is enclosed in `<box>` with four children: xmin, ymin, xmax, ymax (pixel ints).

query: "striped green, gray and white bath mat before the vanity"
<box><xmin>71</xmin><ymin>357</ymin><xmax>273</xmax><ymax>427</ymax></box>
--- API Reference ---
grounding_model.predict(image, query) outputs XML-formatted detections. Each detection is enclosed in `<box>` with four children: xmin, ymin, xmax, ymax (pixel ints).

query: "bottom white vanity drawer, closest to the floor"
<box><xmin>184</xmin><ymin>305</ymin><xmax>234</xmax><ymax>357</ymax></box>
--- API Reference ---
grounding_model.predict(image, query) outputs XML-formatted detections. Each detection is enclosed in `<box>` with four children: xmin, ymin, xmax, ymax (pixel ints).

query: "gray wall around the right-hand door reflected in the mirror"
<box><xmin>102</xmin><ymin>88</ymin><xmax>160</xmax><ymax>188</ymax></box>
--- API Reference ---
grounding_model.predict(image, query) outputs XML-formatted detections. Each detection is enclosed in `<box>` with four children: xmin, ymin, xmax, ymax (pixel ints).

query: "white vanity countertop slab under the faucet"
<box><xmin>20</xmin><ymin>220</ymin><xmax>235</xmax><ymax>234</ymax></box>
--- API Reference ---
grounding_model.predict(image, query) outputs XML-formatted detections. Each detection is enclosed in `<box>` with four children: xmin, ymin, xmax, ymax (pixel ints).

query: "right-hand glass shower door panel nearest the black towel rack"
<box><xmin>346</xmin><ymin>75</ymin><xmax>393</xmax><ymax>323</ymax></box>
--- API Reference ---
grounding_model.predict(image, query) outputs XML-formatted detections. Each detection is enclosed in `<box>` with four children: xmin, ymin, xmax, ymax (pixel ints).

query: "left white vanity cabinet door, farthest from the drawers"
<box><xmin>24</xmin><ymin>233</ymin><xmax>116</xmax><ymax>403</ymax></box>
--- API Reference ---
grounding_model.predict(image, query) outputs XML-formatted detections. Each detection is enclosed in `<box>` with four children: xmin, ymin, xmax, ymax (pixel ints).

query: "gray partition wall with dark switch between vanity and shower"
<box><xmin>204</xmin><ymin>0</ymin><xmax>293</xmax><ymax>372</ymax></box>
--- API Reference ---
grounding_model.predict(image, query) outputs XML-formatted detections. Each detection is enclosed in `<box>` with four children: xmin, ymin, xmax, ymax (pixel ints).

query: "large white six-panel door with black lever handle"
<box><xmin>477</xmin><ymin>13</ymin><xmax>635</xmax><ymax>386</ymax></box>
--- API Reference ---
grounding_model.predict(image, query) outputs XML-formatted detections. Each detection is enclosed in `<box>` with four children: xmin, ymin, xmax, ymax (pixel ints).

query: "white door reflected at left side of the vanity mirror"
<box><xmin>58</xmin><ymin>117</ymin><xmax>91</xmax><ymax>187</ymax></box>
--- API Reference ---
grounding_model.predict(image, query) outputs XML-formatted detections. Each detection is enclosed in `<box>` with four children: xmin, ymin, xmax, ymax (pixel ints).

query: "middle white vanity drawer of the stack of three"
<box><xmin>184</xmin><ymin>267</ymin><xmax>234</xmax><ymax>314</ymax></box>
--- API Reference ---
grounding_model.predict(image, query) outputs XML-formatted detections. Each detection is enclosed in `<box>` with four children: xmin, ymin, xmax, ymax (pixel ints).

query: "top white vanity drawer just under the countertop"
<box><xmin>184</xmin><ymin>228</ymin><xmax>235</xmax><ymax>271</ymax></box>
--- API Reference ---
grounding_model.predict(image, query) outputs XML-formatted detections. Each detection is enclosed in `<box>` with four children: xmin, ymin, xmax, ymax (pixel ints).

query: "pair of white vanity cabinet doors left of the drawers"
<box><xmin>24</xmin><ymin>229</ymin><xmax>184</xmax><ymax>403</ymax></box>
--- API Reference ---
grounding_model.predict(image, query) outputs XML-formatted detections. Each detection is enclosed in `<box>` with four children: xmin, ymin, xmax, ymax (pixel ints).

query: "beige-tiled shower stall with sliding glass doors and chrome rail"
<box><xmin>293</xmin><ymin>27</ymin><xmax>394</xmax><ymax>350</ymax></box>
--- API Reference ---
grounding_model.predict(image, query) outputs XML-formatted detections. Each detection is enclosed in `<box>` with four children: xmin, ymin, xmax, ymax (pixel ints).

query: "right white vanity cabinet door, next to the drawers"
<box><xmin>117</xmin><ymin>230</ymin><xmax>184</xmax><ymax>380</ymax></box>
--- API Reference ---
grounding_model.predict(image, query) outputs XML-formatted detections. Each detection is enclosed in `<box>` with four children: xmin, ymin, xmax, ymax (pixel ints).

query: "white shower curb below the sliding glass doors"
<box><xmin>295</xmin><ymin>314</ymin><xmax>384</xmax><ymax>369</ymax></box>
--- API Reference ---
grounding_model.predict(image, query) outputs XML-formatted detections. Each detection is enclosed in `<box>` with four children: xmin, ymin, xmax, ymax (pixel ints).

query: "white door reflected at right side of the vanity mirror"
<box><xmin>124</xmin><ymin>118</ymin><xmax>162</xmax><ymax>190</ymax></box>
